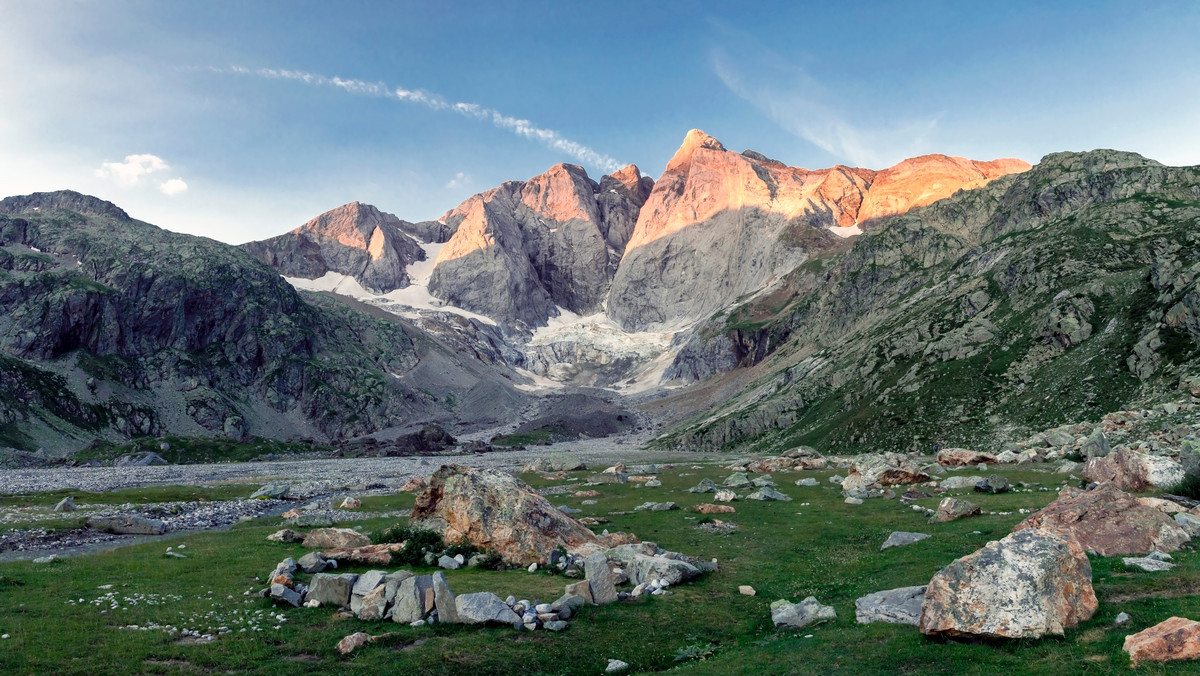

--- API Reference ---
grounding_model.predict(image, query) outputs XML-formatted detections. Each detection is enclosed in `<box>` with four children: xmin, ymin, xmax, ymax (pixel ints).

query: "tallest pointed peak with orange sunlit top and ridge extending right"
<box><xmin>607</xmin><ymin>130</ymin><xmax>1030</xmax><ymax>330</ymax></box>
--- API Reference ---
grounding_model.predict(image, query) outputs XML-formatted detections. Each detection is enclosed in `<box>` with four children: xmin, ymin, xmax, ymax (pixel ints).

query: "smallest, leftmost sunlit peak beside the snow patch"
<box><xmin>241</xmin><ymin>202</ymin><xmax>425</xmax><ymax>293</ymax></box>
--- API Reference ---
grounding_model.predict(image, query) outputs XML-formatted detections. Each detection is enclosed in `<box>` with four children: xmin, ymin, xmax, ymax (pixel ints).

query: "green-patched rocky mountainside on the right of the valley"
<box><xmin>660</xmin><ymin>151</ymin><xmax>1200</xmax><ymax>453</ymax></box>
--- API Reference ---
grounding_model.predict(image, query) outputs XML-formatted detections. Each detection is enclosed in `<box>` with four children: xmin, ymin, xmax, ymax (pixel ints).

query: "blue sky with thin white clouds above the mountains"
<box><xmin>0</xmin><ymin>0</ymin><xmax>1200</xmax><ymax>243</ymax></box>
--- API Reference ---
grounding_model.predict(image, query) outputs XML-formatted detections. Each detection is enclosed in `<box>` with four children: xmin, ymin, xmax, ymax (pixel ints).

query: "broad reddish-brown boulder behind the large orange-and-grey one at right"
<box><xmin>1013</xmin><ymin>484</ymin><xmax>1189</xmax><ymax>556</ymax></box>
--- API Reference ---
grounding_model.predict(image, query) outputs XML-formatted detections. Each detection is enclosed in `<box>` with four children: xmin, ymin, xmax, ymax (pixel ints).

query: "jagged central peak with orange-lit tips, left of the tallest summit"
<box><xmin>430</xmin><ymin>164</ymin><xmax>653</xmax><ymax>327</ymax></box>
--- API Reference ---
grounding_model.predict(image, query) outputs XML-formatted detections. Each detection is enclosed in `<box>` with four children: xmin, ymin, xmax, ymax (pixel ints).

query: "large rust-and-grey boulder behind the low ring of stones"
<box><xmin>409</xmin><ymin>465</ymin><xmax>600</xmax><ymax>567</ymax></box>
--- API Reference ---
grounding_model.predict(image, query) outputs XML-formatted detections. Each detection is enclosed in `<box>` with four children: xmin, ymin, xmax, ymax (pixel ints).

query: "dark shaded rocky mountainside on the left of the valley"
<box><xmin>0</xmin><ymin>192</ymin><xmax>530</xmax><ymax>448</ymax></box>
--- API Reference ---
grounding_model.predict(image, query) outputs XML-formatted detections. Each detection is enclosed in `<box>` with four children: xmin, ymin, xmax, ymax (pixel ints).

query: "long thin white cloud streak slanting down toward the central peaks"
<box><xmin>209</xmin><ymin>66</ymin><xmax>624</xmax><ymax>172</ymax></box>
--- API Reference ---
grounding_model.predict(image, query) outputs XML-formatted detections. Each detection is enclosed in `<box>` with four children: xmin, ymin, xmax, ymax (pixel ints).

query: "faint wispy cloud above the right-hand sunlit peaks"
<box><xmin>712</xmin><ymin>46</ymin><xmax>941</xmax><ymax>168</ymax></box>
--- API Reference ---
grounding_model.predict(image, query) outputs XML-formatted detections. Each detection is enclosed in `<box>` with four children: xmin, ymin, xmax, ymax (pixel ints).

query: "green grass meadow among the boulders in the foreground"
<box><xmin>0</xmin><ymin>462</ymin><xmax>1200</xmax><ymax>676</ymax></box>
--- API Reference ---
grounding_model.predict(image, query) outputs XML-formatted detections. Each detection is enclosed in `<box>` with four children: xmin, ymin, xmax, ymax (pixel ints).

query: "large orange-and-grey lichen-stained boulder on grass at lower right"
<box><xmin>919</xmin><ymin>528</ymin><xmax>1098</xmax><ymax>639</ymax></box>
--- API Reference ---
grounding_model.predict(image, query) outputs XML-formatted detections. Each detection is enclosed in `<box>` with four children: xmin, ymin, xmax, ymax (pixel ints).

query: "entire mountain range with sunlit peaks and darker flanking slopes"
<box><xmin>0</xmin><ymin>130</ymin><xmax>1200</xmax><ymax>458</ymax></box>
